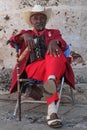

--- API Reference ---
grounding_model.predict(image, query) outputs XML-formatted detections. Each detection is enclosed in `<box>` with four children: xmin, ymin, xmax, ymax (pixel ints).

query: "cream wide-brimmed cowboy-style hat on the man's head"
<box><xmin>24</xmin><ymin>5</ymin><xmax>52</xmax><ymax>26</ymax></box>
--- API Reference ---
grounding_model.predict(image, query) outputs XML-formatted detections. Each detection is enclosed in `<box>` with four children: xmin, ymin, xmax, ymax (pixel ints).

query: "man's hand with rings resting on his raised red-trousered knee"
<box><xmin>47</xmin><ymin>40</ymin><xmax>60</xmax><ymax>56</ymax></box>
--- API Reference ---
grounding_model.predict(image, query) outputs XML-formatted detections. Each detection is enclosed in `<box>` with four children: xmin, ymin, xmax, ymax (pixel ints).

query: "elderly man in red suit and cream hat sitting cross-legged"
<box><xmin>10</xmin><ymin>5</ymin><xmax>74</xmax><ymax>128</ymax></box>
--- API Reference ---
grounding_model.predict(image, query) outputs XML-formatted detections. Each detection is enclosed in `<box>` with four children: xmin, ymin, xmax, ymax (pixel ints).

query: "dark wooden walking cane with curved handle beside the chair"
<box><xmin>7</xmin><ymin>40</ymin><xmax>21</xmax><ymax>121</ymax></box>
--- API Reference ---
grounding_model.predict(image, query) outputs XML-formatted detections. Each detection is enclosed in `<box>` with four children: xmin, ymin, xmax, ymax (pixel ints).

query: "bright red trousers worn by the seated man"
<box><xmin>26</xmin><ymin>53</ymin><xmax>66</xmax><ymax>104</ymax></box>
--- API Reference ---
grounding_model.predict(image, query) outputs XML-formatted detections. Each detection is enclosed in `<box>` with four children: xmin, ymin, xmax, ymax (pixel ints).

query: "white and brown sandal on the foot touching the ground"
<box><xmin>47</xmin><ymin>113</ymin><xmax>63</xmax><ymax>128</ymax></box>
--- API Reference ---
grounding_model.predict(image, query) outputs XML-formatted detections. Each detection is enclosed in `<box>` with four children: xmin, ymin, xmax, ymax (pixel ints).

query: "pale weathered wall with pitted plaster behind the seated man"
<box><xmin>0</xmin><ymin>0</ymin><xmax>87</xmax><ymax>68</ymax></box>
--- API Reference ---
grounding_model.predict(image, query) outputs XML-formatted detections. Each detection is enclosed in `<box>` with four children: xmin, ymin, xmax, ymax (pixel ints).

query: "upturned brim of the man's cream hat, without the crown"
<box><xmin>24</xmin><ymin>8</ymin><xmax>52</xmax><ymax>26</ymax></box>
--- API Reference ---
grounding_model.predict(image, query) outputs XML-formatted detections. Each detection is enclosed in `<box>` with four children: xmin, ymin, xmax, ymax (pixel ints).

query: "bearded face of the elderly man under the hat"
<box><xmin>30</xmin><ymin>13</ymin><xmax>47</xmax><ymax>31</ymax></box>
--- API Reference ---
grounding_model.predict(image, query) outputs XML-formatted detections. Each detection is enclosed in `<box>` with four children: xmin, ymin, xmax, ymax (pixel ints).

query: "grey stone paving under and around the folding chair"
<box><xmin>0</xmin><ymin>92</ymin><xmax>87</xmax><ymax>130</ymax></box>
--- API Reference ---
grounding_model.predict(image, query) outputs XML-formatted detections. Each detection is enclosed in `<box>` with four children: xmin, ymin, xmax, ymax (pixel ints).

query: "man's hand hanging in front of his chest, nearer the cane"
<box><xmin>22</xmin><ymin>33</ymin><xmax>35</xmax><ymax>51</ymax></box>
